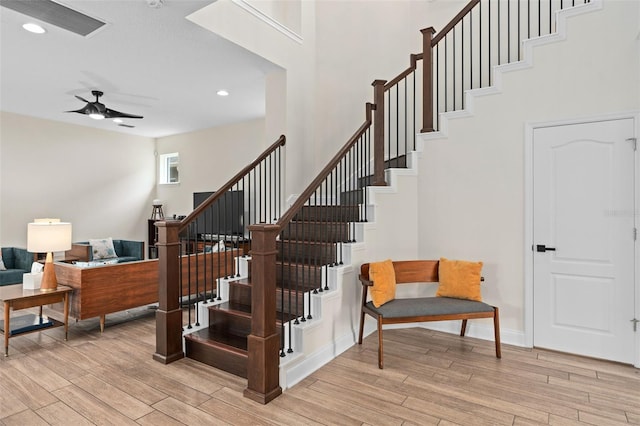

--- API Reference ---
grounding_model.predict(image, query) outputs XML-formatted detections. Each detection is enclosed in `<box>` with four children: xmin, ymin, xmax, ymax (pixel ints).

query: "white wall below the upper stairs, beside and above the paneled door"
<box><xmin>419</xmin><ymin>0</ymin><xmax>640</xmax><ymax>332</ymax></box>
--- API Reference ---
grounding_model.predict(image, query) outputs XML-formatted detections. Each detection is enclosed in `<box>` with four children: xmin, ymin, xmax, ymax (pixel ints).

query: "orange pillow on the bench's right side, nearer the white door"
<box><xmin>436</xmin><ymin>257</ymin><xmax>482</xmax><ymax>302</ymax></box>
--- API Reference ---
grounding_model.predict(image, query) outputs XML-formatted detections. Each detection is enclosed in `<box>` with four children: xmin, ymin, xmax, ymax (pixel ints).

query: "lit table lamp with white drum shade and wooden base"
<box><xmin>27</xmin><ymin>219</ymin><xmax>71</xmax><ymax>291</ymax></box>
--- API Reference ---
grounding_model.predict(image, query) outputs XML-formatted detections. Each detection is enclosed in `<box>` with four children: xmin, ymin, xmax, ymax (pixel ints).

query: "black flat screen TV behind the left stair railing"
<box><xmin>193</xmin><ymin>191</ymin><xmax>244</xmax><ymax>237</ymax></box>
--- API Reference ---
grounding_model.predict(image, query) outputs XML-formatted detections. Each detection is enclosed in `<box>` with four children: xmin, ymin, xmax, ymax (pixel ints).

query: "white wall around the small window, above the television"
<box><xmin>156</xmin><ymin>119</ymin><xmax>268</xmax><ymax>217</ymax></box>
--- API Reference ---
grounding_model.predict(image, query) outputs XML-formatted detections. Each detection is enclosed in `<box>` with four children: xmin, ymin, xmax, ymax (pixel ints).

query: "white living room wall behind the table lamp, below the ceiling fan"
<box><xmin>0</xmin><ymin>112</ymin><xmax>155</xmax><ymax>247</ymax></box>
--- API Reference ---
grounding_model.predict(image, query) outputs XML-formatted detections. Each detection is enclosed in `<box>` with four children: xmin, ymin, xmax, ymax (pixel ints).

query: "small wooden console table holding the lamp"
<box><xmin>0</xmin><ymin>284</ymin><xmax>73</xmax><ymax>356</ymax></box>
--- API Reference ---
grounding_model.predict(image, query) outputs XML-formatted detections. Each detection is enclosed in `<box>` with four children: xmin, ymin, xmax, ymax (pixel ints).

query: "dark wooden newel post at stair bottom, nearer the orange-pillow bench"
<box><xmin>244</xmin><ymin>223</ymin><xmax>282</xmax><ymax>404</ymax></box>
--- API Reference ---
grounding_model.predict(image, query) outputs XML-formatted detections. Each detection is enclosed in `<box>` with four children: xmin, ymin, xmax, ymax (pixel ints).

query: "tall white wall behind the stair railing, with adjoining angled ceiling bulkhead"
<box><xmin>189</xmin><ymin>0</ymin><xmax>440</xmax><ymax>194</ymax></box>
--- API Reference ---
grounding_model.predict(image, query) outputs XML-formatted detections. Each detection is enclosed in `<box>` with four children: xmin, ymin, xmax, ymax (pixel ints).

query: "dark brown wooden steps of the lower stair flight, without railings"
<box><xmin>185</xmin><ymin>194</ymin><xmax>362</xmax><ymax>378</ymax></box>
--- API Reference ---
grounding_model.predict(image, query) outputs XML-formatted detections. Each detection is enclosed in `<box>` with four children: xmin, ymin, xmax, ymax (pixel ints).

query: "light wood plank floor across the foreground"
<box><xmin>0</xmin><ymin>309</ymin><xmax>640</xmax><ymax>425</ymax></box>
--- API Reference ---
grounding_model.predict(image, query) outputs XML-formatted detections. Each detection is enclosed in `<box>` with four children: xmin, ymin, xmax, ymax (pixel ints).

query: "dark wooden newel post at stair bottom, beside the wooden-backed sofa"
<box><xmin>153</xmin><ymin>221</ymin><xmax>184</xmax><ymax>364</ymax></box>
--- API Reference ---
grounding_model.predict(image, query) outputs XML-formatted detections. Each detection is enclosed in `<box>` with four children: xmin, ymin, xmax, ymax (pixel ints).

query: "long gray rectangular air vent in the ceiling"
<box><xmin>0</xmin><ymin>0</ymin><xmax>105</xmax><ymax>36</ymax></box>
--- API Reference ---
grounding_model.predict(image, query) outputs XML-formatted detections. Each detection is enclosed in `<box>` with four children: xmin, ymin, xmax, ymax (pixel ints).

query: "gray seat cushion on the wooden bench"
<box><xmin>367</xmin><ymin>297</ymin><xmax>493</xmax><ymax>318</ymax></box>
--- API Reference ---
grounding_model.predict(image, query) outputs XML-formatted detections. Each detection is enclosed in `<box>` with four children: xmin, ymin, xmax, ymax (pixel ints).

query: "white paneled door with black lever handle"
<box><xmin>532</xmin><ymin>119</ymin><xmax>640</xmax><ymax>363</ymax></box>
